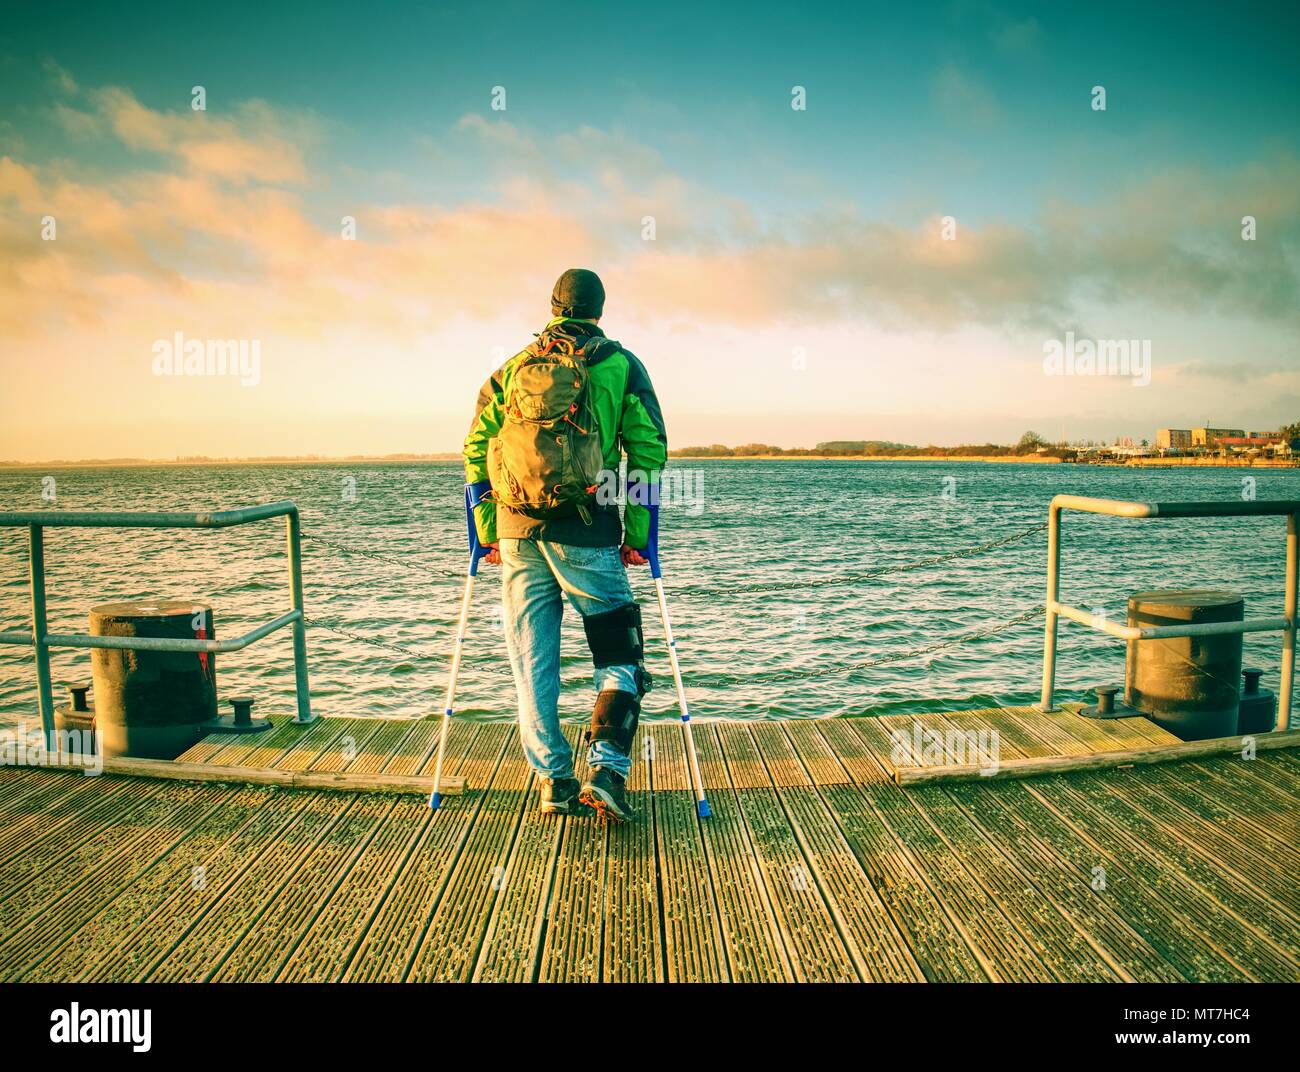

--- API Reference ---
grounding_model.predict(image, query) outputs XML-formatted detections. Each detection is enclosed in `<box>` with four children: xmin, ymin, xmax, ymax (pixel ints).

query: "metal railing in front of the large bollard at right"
<box><xmin>1040</xmin><ymin>495</ymin><xmax>1300</xmax><ymax>730</ymax></box>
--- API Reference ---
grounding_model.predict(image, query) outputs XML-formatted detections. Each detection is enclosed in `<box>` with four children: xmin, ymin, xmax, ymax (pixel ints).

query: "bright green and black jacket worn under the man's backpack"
<box><xmin>464</xmin><ymin>317</ymin><xmax>668</xmax><ymax>550</ymax></box>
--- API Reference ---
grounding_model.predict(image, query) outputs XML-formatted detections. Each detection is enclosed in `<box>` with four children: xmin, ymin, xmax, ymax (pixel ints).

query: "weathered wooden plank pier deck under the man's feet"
<box><xmin>0</xmin><ymin>708</ymin><xmax>1300</xmax><ymax>982</ymax></box>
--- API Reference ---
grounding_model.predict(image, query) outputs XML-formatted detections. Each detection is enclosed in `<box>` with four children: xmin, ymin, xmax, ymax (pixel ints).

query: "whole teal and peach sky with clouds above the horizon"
<box><xmin>0</xmin><ymin>0</ymin><xmax>1300</xmax><ymax>461</ymax></box>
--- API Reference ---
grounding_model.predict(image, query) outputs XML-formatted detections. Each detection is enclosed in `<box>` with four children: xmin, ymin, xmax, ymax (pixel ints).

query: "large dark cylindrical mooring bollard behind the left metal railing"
<box><xmin>90</xmin><ymin>599</ymin><xmax>217</xmax><ymax>759</ymax></box>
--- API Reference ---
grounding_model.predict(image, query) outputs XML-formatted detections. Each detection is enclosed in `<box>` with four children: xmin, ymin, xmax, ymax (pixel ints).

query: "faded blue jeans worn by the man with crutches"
<box><xmin>499</xmin><ymin>538</ymin><xmax>637</xmax><ymax>778</ymax></box>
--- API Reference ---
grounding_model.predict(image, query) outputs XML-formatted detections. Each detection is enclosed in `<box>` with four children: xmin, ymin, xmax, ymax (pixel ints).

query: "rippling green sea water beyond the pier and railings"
<box><xmin>0</xmin><ymin>459</ymin><xmax>1300</xmax><ymax>724</ymax></box>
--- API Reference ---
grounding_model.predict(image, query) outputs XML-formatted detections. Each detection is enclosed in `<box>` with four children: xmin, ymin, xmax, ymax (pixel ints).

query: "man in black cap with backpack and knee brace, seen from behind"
<box><xmin>464</xmin><ymin>268</ymin><xmax>668</xmax><ymax>821</ymax></box>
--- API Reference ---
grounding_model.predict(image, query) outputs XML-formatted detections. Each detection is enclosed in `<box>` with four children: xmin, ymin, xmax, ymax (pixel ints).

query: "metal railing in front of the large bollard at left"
<box><xmin>0</xmin><ymin>502</ymin><xmax>313</xmax><ymax>751</ymax></box>
